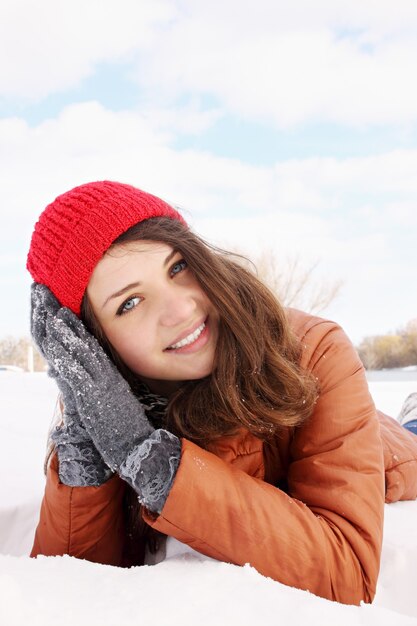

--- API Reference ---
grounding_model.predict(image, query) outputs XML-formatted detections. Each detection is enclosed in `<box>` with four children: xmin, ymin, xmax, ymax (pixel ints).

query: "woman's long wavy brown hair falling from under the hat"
<box><xmin>81</xmin><ymin>218</ymin><xmax>317</xmax><ymax>446</ymax></box>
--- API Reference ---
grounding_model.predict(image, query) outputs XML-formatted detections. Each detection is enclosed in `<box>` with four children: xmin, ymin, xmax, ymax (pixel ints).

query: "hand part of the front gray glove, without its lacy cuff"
<box><xmin>43</xmin><ymin>308</ymin><xmax>154</xmax><ymax>471</ymax></box>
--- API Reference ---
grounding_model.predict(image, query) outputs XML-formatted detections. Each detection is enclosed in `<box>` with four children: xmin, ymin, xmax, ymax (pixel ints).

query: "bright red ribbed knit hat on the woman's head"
<box><xmin>27</xmin><ymin>180</ymin><xmax>185</xmax><ymax>315</ymax></box>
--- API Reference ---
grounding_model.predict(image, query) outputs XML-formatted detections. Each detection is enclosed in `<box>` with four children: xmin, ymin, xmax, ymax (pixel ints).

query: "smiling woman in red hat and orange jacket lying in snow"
<box><xmin>28</xmin><ymin>181</ymin><xmax>417</xmax><ymax>604</ymax></box>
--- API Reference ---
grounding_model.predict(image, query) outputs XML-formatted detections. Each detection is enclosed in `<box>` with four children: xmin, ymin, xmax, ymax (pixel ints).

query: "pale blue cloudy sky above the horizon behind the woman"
<box><xmin>0</xmin><ymin>0</ymin><xmax>417</xmax><ymax>342</ymax></box>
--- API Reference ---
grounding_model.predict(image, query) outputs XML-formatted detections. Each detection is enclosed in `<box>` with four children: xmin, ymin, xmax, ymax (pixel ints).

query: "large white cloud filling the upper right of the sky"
<box><xmin>123</xmin><ymin>0</ymin><xmax>417</xmax><ymax>128</ymax></box>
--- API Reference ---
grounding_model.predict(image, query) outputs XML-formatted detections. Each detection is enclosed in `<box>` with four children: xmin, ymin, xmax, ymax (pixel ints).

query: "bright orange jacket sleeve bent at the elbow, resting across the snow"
<box><xmin>145</xmin><ymin>318</ymin><xmax>384</xmax><ymax>604</ymax></box>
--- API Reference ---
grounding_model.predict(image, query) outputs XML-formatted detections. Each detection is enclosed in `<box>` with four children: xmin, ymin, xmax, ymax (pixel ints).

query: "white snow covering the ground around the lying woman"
<box><xmin>0</xmin><ymin>371</ymin><xmax>417</xmax><ymax>626</ymax></box>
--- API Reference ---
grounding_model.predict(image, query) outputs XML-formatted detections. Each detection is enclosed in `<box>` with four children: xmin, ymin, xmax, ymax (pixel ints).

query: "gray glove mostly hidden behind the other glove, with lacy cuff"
<box><xmin>31</xmin><ymin>283</ymin><xmax>113</xmax><ymax>487</ymax></box>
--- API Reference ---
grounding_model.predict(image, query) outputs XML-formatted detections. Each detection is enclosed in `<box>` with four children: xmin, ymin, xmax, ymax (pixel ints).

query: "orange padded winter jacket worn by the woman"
<box><xmin>31</xmin><ymin>310</ymin><xmax>417</xmax><ymax>604</ymax></box>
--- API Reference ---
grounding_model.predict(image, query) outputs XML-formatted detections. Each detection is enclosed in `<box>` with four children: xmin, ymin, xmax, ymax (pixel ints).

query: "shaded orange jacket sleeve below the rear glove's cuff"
<box><xmin>31</xmin><ymin>448</ymin><xmax>124</xmax><ymax>565</ymax></box>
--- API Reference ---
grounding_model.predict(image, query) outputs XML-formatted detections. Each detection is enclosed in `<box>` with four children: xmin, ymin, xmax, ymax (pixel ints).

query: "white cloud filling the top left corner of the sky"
<box><xmin>0</xmin><ymin>0</ymin><xmax>174</xmax><ymax>100</ymax></box>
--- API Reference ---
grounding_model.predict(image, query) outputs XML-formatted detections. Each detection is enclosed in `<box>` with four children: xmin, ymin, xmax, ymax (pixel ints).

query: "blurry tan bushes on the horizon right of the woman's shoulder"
<box><xmin>357</xmin><ymin>319</ymin><xmax>417</xmax><ymax>370</ymax></box>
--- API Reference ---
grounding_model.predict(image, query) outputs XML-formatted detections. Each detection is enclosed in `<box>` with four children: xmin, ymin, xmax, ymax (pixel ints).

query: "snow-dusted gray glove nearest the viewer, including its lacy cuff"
<box><xmin>43</xmin><ymin>308</ymin><xmax>181</xmax><ymax>513</ymax></box>
